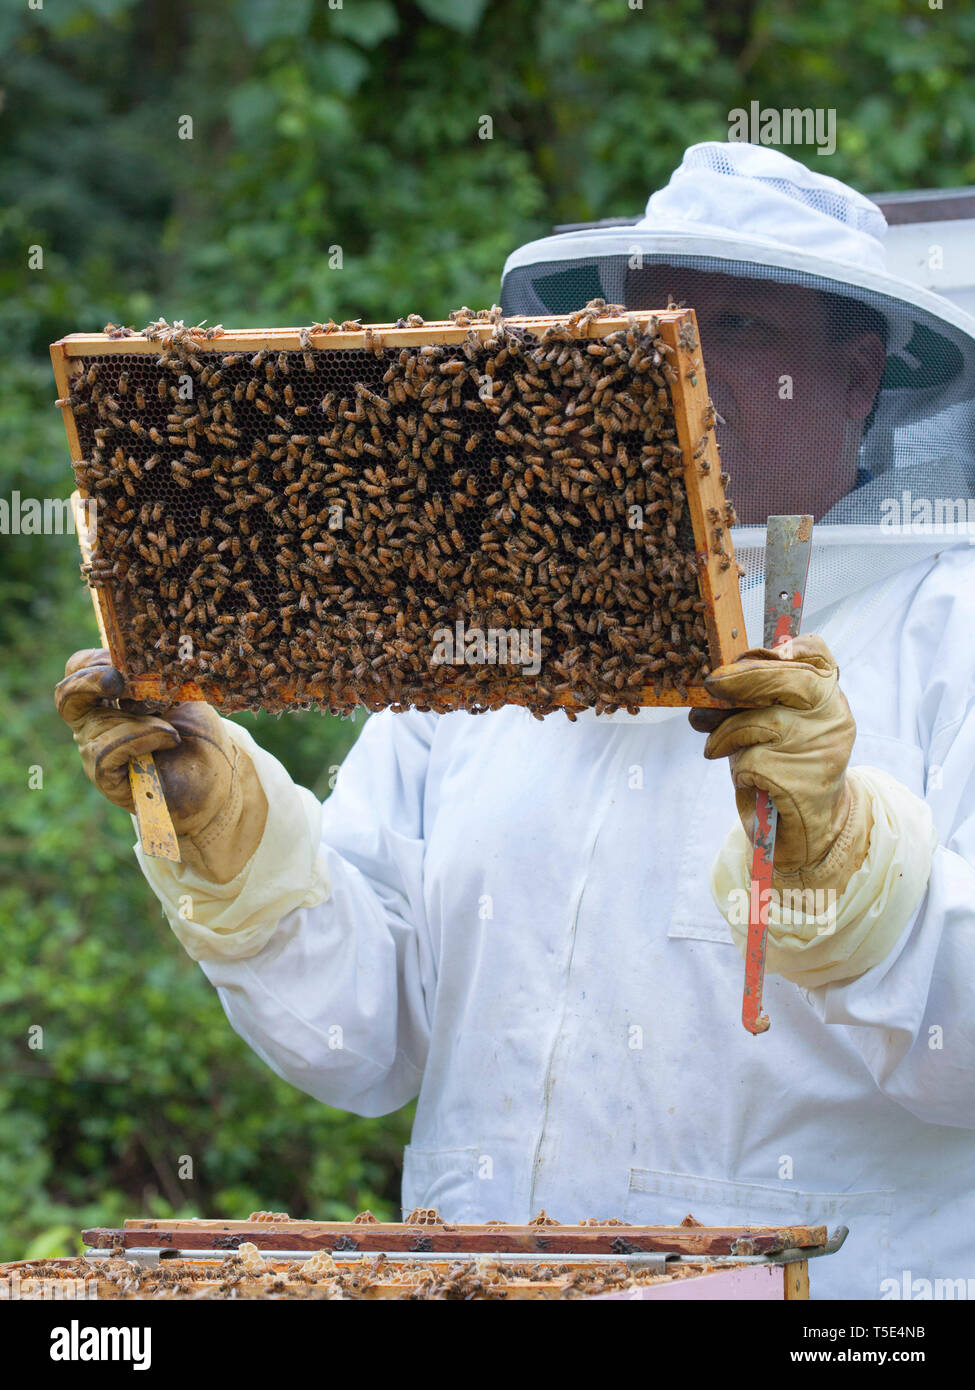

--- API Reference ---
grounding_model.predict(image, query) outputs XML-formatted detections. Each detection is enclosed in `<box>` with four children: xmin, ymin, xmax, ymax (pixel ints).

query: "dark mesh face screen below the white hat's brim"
<box><xmin>502</xmin><ymin>252</ymin><xmax>975</xmax><ymax>528</ymax></box>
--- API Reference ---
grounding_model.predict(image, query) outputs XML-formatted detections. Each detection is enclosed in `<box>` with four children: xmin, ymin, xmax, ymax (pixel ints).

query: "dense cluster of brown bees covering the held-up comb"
<box><xmin>68</xmin><ymin>300</ymin><xmax>727</xmax><ymax>717</ymax></box>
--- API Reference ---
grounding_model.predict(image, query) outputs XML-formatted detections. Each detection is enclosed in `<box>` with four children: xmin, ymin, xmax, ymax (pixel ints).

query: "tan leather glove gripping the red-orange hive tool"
<box><xmin>690</xmin><ymin>634</ymin><xmax>873</xmax><ymax>895</ymax></box>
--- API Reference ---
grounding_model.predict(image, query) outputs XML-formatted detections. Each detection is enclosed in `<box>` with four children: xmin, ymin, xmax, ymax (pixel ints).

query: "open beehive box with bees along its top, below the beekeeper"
<box><xmin>0</xmin><ymin>1208</ymin><xmax>826</xmax><ymax>1301</ymax></box>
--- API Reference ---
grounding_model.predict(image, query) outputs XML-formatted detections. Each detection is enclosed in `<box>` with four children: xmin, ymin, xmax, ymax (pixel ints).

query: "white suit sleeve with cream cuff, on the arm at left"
<box><xmin>137</xmin><ymin>712</ymin><xmax>435</xmax><ymax>1115</ymax></box>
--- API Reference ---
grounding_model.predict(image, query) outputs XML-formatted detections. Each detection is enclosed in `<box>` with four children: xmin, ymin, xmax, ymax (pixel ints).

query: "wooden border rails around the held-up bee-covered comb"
<box><xmin>50</xmin><ymin>309</ymin><xmax>747</xmax><ymax>708</ymax></box>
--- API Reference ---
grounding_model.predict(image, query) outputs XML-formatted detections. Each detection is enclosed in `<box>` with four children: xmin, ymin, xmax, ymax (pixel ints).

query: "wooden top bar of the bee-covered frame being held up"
<box><xmin>51</xmin><ymin>309</ymin><xmax>693</xmax><ymax>357</ymax></box>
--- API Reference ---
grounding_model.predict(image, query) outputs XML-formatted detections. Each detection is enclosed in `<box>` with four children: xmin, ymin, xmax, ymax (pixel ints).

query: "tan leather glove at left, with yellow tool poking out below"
<box><xmin>54</xmin><ymin>649</ymin><xmax>267</xmax><ymax>883</ymax></box>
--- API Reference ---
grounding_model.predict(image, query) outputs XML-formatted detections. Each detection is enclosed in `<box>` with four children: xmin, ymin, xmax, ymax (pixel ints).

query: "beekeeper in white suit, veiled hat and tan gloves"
<box><xmin>58</xmin><ymin>143</ymin><xmax>975</xmax><ymax>1298</ymax></box>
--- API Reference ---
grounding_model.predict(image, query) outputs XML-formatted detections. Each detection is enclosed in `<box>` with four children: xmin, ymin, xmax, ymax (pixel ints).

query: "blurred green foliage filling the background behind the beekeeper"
<box><xmin>0</xmin><ymin>0</ymin><xmax>975</xmax><ymax>1258</ymax></box>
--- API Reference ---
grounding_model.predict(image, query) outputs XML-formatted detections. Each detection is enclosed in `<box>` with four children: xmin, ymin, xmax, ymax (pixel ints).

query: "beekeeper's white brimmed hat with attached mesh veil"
<box><xmin>501</xmin><ymin>142</ymin><xmax>975</xmax><ymax>642</ymax></box>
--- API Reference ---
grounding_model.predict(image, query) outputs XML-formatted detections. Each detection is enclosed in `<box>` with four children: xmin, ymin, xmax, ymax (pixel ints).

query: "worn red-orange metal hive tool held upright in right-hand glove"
<box><xmin>741</xmin><ymin>516</ymin><xmax>812</xmax><ymax>1033</ymax></box>
